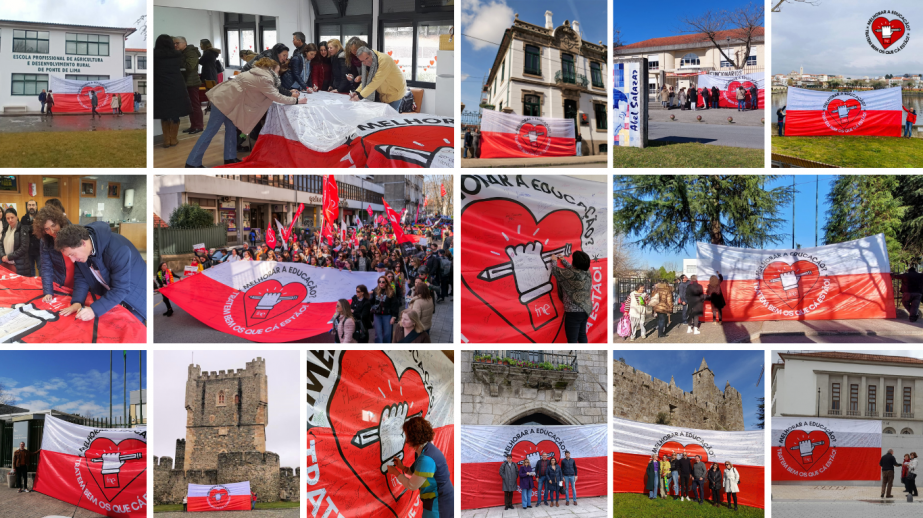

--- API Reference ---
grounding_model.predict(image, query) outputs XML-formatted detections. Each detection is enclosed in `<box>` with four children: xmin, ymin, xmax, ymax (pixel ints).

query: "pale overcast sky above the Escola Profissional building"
<box><xmin>0</xmin><ymin>0</ymin><xmax>147</xmax><ymax>49</ymax></box>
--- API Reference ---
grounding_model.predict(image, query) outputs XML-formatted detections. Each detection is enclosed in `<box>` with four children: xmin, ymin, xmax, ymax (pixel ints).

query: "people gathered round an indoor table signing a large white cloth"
<box><xmin>154</xmin><ymin>32</ymin><xmax>416</xmax><ymax>168</ymax></box>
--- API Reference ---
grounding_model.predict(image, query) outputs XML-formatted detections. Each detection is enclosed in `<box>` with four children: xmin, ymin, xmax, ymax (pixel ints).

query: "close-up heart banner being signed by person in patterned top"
<box><xmin>460</xmin><ymin>175</ymin><xmax>609</xmax><ymax>343</ymax></box>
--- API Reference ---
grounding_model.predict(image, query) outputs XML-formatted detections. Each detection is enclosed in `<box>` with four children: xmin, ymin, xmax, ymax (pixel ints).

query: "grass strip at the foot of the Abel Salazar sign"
<box><xmin>612</xmin><ymin>141</ymin><xmax>765</xmax><ymax>168</ymax></box>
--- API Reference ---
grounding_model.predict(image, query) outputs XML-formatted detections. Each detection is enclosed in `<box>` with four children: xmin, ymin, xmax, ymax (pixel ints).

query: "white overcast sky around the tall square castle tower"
<box><xmin>151</xmin><ymin>351</ymin><xmax>304</xmax><ymax>469</ymax></box>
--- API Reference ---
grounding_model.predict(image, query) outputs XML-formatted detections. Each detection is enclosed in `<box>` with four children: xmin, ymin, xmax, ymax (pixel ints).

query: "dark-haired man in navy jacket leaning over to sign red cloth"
<box><xmin>55</xmin><ymin>221</ymin><xmax>147</xmax><ymax>325</ymax></box>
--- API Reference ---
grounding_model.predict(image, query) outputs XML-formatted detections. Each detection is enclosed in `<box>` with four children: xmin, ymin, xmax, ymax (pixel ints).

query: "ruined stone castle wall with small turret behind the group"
<box><xmin>612</xmin><ymin>358</ymin><xmax>744</xmax><ymax>431</ymax></box>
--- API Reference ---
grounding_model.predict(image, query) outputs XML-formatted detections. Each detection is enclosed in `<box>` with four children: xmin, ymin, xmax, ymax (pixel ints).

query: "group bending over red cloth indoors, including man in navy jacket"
<box><xmin>0</xmin><ymin>198</ymin><xmax>147</xmax><ymax>323</ymax></box>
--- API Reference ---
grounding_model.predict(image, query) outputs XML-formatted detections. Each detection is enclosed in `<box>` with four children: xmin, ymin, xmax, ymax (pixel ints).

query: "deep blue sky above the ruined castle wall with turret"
<box><xmin>612</xmin><ymin>349</ymin><xmax>766</xmax><ymax>430</ymax></box>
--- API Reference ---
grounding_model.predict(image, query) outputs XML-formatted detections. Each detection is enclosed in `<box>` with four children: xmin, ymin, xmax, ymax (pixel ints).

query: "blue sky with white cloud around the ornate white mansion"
<box><xmin>461</xmin><ymin>0</ymin><xmax>612</xmax><ymax>111</ymax></box>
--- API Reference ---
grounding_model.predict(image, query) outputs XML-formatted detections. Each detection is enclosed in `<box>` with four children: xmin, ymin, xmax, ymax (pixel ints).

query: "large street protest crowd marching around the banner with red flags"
<box><xmin>155</xmin><ymin>220</ymin><xmax>454</xmax><ymax>343</ymax></box>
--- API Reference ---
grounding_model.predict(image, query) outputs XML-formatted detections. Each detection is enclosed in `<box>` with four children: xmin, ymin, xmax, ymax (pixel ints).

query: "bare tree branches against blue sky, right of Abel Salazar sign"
<box><xmin>678</xmin><ymin>2</ymin><xmax>765</xmax><ymax>70</ymax></box>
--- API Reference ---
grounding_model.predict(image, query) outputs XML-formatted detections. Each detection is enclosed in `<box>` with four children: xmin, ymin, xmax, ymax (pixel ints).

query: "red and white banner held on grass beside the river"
<box><xmin>785</xmin><ymin>86</ymin><xmax>903</xmax><ymax>137</ymax></box>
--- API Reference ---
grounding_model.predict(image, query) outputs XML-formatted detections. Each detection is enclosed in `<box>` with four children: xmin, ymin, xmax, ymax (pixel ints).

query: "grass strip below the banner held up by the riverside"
<box><xmin>772</xmin><ymin>124</ymin><xmax>923</xmax><ymax>167</ymax></box>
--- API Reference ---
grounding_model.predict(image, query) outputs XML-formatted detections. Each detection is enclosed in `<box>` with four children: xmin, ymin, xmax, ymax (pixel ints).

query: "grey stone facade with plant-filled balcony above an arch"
<box><xmin>461</xmin><ymin>351</ymin><xmax>607</xmax><ymax>425</ymax></box>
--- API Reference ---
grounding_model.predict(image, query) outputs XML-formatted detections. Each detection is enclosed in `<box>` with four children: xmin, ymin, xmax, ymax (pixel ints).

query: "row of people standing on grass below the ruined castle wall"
<box><xmin>644</xmin><ymin>453</ymin><xmax>740</xmax><ymax>511</ymax></box>
